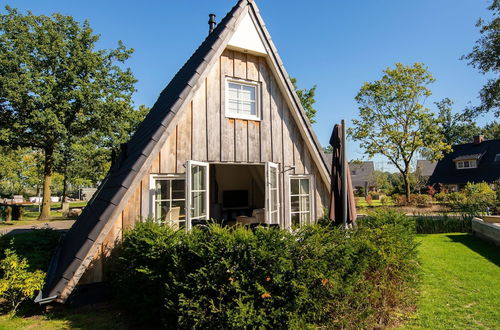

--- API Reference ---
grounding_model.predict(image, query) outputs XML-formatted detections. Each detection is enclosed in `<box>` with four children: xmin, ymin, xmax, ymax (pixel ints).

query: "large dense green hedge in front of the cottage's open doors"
<box><xmin>109</xmin><ymin>211</ymin><xmax>419</xmax><ymax>328</ymax></box>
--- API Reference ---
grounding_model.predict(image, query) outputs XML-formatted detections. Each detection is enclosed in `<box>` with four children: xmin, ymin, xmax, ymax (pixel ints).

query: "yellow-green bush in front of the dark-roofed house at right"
<box><xmin>445</xmin><ymin>182</ymin><xmax>496</xmax><ymax>217</ymax></box>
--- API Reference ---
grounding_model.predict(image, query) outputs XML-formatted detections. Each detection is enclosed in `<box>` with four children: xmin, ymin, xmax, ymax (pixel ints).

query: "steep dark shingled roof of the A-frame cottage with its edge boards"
<box><xmin>36</xmin><ymin>0</ymin><xmax>328</xmax><ymax>303</ymax></box>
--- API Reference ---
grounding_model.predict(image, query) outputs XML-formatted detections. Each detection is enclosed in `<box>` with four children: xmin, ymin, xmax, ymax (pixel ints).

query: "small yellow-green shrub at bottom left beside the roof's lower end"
<box><xmin>0</xmin><ymin>249</ymin><xmax>45</xmax><ymax>313</ymax></box>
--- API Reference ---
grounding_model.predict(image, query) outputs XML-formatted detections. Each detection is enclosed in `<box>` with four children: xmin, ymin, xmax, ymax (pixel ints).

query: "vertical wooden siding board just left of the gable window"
<box><xmin>207</xmin><ymin>59</ymin><xmax>221</xmax><ymax>161</ymax></box>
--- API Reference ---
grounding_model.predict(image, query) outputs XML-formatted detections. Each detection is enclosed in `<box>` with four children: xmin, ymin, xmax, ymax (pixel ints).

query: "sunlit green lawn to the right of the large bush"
<box><xmin>404</xmin><ymin>233</ymin><xmax>500</xmax><ymax>329</ymax></box>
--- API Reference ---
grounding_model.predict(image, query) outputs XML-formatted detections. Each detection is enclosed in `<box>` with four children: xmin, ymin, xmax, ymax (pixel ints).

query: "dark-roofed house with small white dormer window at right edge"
<box><xmin>429</xmin><ymin>135</ymin><xmax>500</xmax><ymax>191</ymax></box>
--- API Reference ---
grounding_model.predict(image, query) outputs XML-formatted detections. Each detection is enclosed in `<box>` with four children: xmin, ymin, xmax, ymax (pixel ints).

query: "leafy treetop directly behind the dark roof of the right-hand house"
<box><xmin>435</xmin><ymin>98</ymin><xmax>481</xmax><ymax>145</ymax></box>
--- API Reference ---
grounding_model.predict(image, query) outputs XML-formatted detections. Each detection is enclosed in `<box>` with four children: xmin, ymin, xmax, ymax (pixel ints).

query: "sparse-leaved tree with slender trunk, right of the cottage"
<box><xmin>349</xmin><ymin>63</ymin><xmax>450</xmax><ymax>202</ymax></box>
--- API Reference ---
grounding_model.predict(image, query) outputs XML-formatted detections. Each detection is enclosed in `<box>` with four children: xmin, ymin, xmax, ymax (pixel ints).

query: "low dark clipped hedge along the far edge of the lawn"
<box><xmin>415</xmin><ymin>215</ymin><xmax>472</xmax><ymax>234</ymax></box>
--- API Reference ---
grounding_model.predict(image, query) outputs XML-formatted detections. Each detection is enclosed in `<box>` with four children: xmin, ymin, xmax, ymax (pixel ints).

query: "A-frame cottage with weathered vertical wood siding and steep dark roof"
<box><xmin>37</xmin><ymin>0</ymin><xmax>330</xmax><ymax>303</ymax></box>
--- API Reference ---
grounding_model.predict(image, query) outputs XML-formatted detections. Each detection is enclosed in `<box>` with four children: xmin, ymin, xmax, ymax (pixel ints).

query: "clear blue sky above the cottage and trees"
<box><xmin>0</xmin><ymin>0</ymin><xmax>494</xmax><ymax>171</ymax></box>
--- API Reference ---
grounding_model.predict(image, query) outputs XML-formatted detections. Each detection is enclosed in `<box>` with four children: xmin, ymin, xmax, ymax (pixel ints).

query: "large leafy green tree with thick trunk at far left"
<box><xmin>0</xmin><ymin>6</ymin><xmax>136</xmax><ymax>220</ymax></box>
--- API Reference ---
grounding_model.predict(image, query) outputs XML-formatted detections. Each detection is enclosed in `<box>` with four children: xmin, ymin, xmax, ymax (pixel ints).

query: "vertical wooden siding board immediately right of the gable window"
<box><xmin>259</xmin><ymin>57</ymin><xmax>272</xmax><ymax>162</ymax></box>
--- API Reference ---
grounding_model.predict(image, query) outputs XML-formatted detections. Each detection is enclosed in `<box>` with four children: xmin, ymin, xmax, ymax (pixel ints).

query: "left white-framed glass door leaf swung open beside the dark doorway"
<box><xmin>186</xmin><ymin>160</ymin><xmax>210</xmax><ymax>230</ymax></box>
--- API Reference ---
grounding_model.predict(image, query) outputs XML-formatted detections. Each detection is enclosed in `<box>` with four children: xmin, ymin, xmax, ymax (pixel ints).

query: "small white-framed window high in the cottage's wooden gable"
<box><xmin>226</xmin><ymin>79</ymin><xmax>260</xmax><ymax>120</ymax></box>
